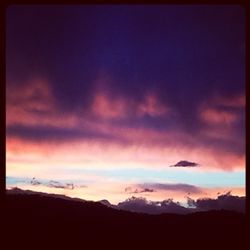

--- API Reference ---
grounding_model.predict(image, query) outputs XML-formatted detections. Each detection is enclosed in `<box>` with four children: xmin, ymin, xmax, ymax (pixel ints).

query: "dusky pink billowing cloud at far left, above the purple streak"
<box><xmin>6</xmin><ymin>79</ymin><xmax>80</xmax><ymax>128</ymax></box>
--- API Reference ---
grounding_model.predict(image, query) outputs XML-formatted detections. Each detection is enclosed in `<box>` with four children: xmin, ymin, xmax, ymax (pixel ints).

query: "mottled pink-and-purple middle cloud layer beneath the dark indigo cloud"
<box><xmin>6</xmin><ymin>77</ymin><xmax>245</xmax><ymax>170</ymax></box>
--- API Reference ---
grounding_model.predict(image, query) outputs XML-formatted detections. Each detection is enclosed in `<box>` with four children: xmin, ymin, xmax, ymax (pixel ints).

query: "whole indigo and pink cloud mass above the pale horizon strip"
<box><xmin>6</xmin><ymin>6</ymin><xmax>245</xmax><ymax>174</ymax></box>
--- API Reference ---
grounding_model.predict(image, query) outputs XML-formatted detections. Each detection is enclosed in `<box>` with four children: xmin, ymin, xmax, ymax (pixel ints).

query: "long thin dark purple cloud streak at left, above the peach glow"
<box><xmin>6</xmin><ymin>125</ymin><xmax>122</xmax><ymax>142</ymax></box>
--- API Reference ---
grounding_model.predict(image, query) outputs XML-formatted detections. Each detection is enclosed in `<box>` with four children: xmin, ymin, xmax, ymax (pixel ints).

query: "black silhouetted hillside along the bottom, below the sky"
<box><xmin>2</xmin><ymin>189</ymin><xmax>246</xmax><ymax>249</ymax></box>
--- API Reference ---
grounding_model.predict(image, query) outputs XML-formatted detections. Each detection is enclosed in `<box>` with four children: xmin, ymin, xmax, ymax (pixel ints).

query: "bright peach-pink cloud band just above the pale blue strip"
<box><xmin>6</xmin><ymin>129</ymin><xmax>245</xmax><ymax>171</ymax></box>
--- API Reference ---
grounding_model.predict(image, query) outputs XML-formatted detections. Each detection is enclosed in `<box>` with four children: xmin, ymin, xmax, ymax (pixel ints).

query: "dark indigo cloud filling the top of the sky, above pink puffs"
<box><xmin>6</xmin><ymin>7</ymin><xmax>245</xmax><ymax>131</ymax></box>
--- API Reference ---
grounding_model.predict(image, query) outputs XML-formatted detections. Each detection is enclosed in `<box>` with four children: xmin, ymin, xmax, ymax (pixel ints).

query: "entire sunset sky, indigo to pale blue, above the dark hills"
<box><xmin>6</xmin><ymin>5</ymin><xmax>246</xmax><ymax>204</ymax></box>
